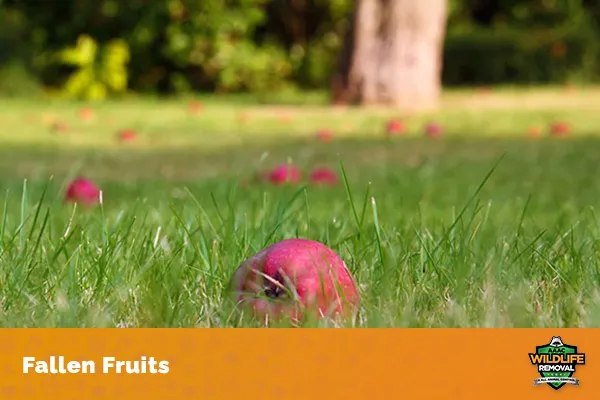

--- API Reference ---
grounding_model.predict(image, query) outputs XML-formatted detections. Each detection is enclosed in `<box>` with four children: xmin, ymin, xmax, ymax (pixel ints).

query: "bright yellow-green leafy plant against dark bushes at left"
<box><xmin>56</xmin><ymin>35</ymin><xmax>129</xmax><ymax>100</ymax></box>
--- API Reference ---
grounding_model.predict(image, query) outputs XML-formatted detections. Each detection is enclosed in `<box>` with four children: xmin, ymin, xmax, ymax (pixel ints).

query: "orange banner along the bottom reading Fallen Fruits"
<box><xmin>0</xmin><ymin>329</ymin><xmax>600</xmax><ymax>400</ymax></box>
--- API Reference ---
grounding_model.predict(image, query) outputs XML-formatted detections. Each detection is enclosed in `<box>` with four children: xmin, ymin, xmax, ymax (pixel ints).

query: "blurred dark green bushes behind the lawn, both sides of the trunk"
<box><xmin>0</xmin><ymin>0</ymin><xmax>600</xmax><ymax>98</ymax></box>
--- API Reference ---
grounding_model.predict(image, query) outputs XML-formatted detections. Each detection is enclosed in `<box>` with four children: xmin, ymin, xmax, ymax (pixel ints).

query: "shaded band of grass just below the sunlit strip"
<box><xmin>0</xmin><ymin>138</ymin><xmax>600</xmax><ymax>182</ymax></box>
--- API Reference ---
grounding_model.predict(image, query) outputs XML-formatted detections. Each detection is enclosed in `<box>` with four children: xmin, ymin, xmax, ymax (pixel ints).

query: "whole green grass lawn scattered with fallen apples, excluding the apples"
<box><xmin>0</xmin><ymin>88</ymin><xmax>600</xmax><ymax>327</ymax></box>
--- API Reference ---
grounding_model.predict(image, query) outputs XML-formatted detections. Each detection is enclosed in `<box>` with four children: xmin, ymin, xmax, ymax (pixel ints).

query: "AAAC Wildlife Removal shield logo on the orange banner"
<box><xmin>529</xmin><ymin>336</ymin><xmax>585</xmax><ymax>390</ymax></box>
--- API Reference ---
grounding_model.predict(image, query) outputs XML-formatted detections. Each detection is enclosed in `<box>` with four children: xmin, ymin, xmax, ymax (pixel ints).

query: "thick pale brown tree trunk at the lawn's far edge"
<box><xmin>332</xmin><ymin>0</ymin><xmax>447</xmax><ymax>109</ymax></box>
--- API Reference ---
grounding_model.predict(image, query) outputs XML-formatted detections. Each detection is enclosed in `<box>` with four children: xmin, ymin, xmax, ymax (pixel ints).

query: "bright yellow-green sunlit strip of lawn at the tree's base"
<box><xmin>0</xmin><ymin>87</ymin><xmax>600</xmax><ymax>149</ymax></box>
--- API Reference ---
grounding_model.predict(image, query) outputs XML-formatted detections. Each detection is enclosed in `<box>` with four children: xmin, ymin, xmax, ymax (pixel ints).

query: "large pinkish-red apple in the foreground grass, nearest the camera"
<box><xmin>229</xmin><ymin>239</ymin><xmax>360</xmax><ymax>322</ymax></box>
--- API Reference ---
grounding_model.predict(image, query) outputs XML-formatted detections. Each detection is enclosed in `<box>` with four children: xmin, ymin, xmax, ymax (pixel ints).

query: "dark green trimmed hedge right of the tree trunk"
<box><xmin>443</xmin><ymin>29</ymin><xmax>600</xmax><ymax>85</ymax></box>
